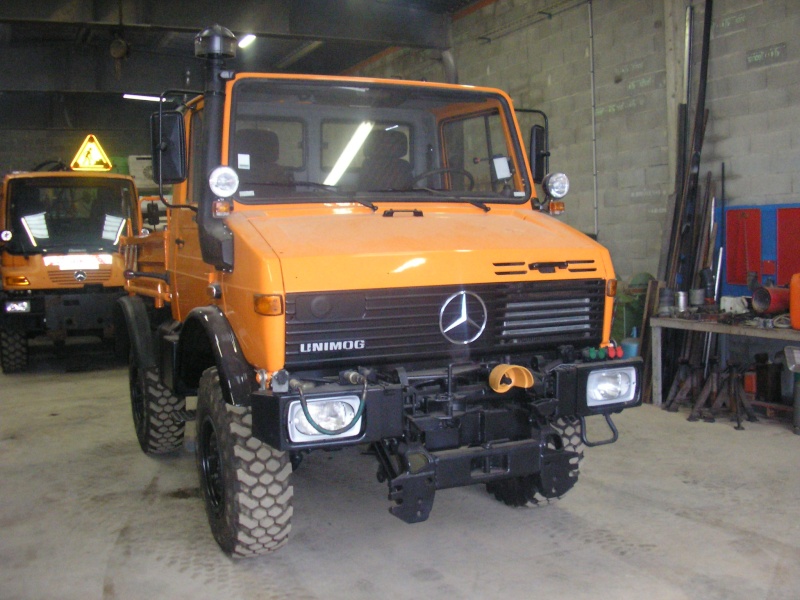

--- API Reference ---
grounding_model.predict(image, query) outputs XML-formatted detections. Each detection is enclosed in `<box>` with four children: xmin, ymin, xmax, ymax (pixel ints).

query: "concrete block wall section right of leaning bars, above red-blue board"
<box><xmin>695</xmin><ymin>0</ymin><xmax>800</xmax><ymax>206</ymax></box>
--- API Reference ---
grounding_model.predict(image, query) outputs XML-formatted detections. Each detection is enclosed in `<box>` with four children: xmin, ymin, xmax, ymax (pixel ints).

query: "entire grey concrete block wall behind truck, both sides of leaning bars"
<box><xmin>359</xmin><ymin>0</ymin><xmax>800</xmax><ymax>279</ymax></box>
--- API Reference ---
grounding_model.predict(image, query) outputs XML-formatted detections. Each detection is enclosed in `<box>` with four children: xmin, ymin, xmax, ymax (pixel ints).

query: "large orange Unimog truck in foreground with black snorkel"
<box><xmin>120</xmin><ymin>26</ymin><xmax>641</xmax><ymax>556</ymax></box>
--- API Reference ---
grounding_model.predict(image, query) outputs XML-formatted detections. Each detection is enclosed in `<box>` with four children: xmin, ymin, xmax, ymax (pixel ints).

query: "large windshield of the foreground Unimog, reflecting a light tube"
<box><xmin>228</xmin><ymin>79</ymin><xmax>530</xmax><ymax>203</ymax></box>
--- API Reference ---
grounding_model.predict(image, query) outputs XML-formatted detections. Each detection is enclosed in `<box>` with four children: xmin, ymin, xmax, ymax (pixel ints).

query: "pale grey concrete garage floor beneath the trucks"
<box><xmin>0</xmin><ymin>342</ymin><xmax>800</xmax><ymax>600</ymax></box>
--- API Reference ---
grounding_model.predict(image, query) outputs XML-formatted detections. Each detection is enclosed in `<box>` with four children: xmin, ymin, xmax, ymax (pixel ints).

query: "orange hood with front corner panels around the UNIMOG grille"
<box><xmin>219</xmin><ymin>205</ymin><xmax>614</xmax><ymax>372</ymax></box>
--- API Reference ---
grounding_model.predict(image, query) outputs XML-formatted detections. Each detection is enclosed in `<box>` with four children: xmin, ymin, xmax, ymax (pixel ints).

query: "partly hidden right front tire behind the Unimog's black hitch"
<box><xmin>486</xmin><ymin>417</ymin><xmax>584</xmax><ymax>507</ymax></box>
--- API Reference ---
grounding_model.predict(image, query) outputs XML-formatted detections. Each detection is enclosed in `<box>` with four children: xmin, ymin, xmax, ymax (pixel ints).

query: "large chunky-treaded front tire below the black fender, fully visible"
<box><xmin>196</xmin><ymin>367</ymin><xmax>294</xmax><ymax>558</ymax></box>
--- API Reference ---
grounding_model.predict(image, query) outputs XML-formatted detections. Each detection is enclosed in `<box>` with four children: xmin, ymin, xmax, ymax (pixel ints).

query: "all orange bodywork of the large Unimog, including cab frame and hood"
<box><xmin>126</xmin><ymin>73</ymin><xmax>615</xmax><ymax>373</ymax></box>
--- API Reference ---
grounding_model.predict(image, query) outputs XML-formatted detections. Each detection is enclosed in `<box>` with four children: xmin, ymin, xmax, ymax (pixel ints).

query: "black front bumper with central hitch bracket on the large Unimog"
<box><xmin>251</xmin><ymin>358</ymin><xmax>642</xmax><ymax>523</ymax></box>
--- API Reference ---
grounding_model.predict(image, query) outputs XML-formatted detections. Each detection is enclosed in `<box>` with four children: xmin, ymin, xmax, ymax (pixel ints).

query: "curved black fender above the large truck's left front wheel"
<box><xmin>176</xmin><ymin>306</ymin><xmax>255</xmax><ymax>406</ymax></box>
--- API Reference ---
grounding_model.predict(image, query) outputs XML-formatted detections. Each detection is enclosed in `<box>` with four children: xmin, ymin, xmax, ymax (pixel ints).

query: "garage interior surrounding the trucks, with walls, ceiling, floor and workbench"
<box><xmin>0</xmin><ymin>0</ymin><xmax>800</xmax><ymax>600</ymax></box>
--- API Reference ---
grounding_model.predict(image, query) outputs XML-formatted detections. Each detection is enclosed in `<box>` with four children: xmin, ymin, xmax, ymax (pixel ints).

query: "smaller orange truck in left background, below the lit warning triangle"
<box><xmin>0</xmin><ymin>171</ymin><xmax>136</xmax><ymax>373</ymax></box>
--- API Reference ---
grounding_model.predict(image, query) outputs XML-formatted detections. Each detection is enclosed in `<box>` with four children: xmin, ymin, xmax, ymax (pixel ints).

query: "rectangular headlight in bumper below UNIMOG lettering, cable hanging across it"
<box><xmin>288</xmin><ymin>396</ymin><xmax>361</xmax><ymax>442</ymax></box>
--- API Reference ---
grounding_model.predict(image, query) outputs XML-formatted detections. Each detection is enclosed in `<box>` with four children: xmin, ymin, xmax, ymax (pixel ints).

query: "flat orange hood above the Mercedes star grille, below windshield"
<box><xmin>238</xmin><ymin>206</ymin><xmax>614</xmax><ymax>292</ymax></box>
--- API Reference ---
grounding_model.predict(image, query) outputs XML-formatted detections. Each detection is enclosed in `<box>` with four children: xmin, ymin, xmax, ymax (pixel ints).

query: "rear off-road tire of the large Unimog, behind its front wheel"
<box><xmin>128</xmin><ymin>355</ymin><xmax>186</xmax><ymax>454</ymax></box>
